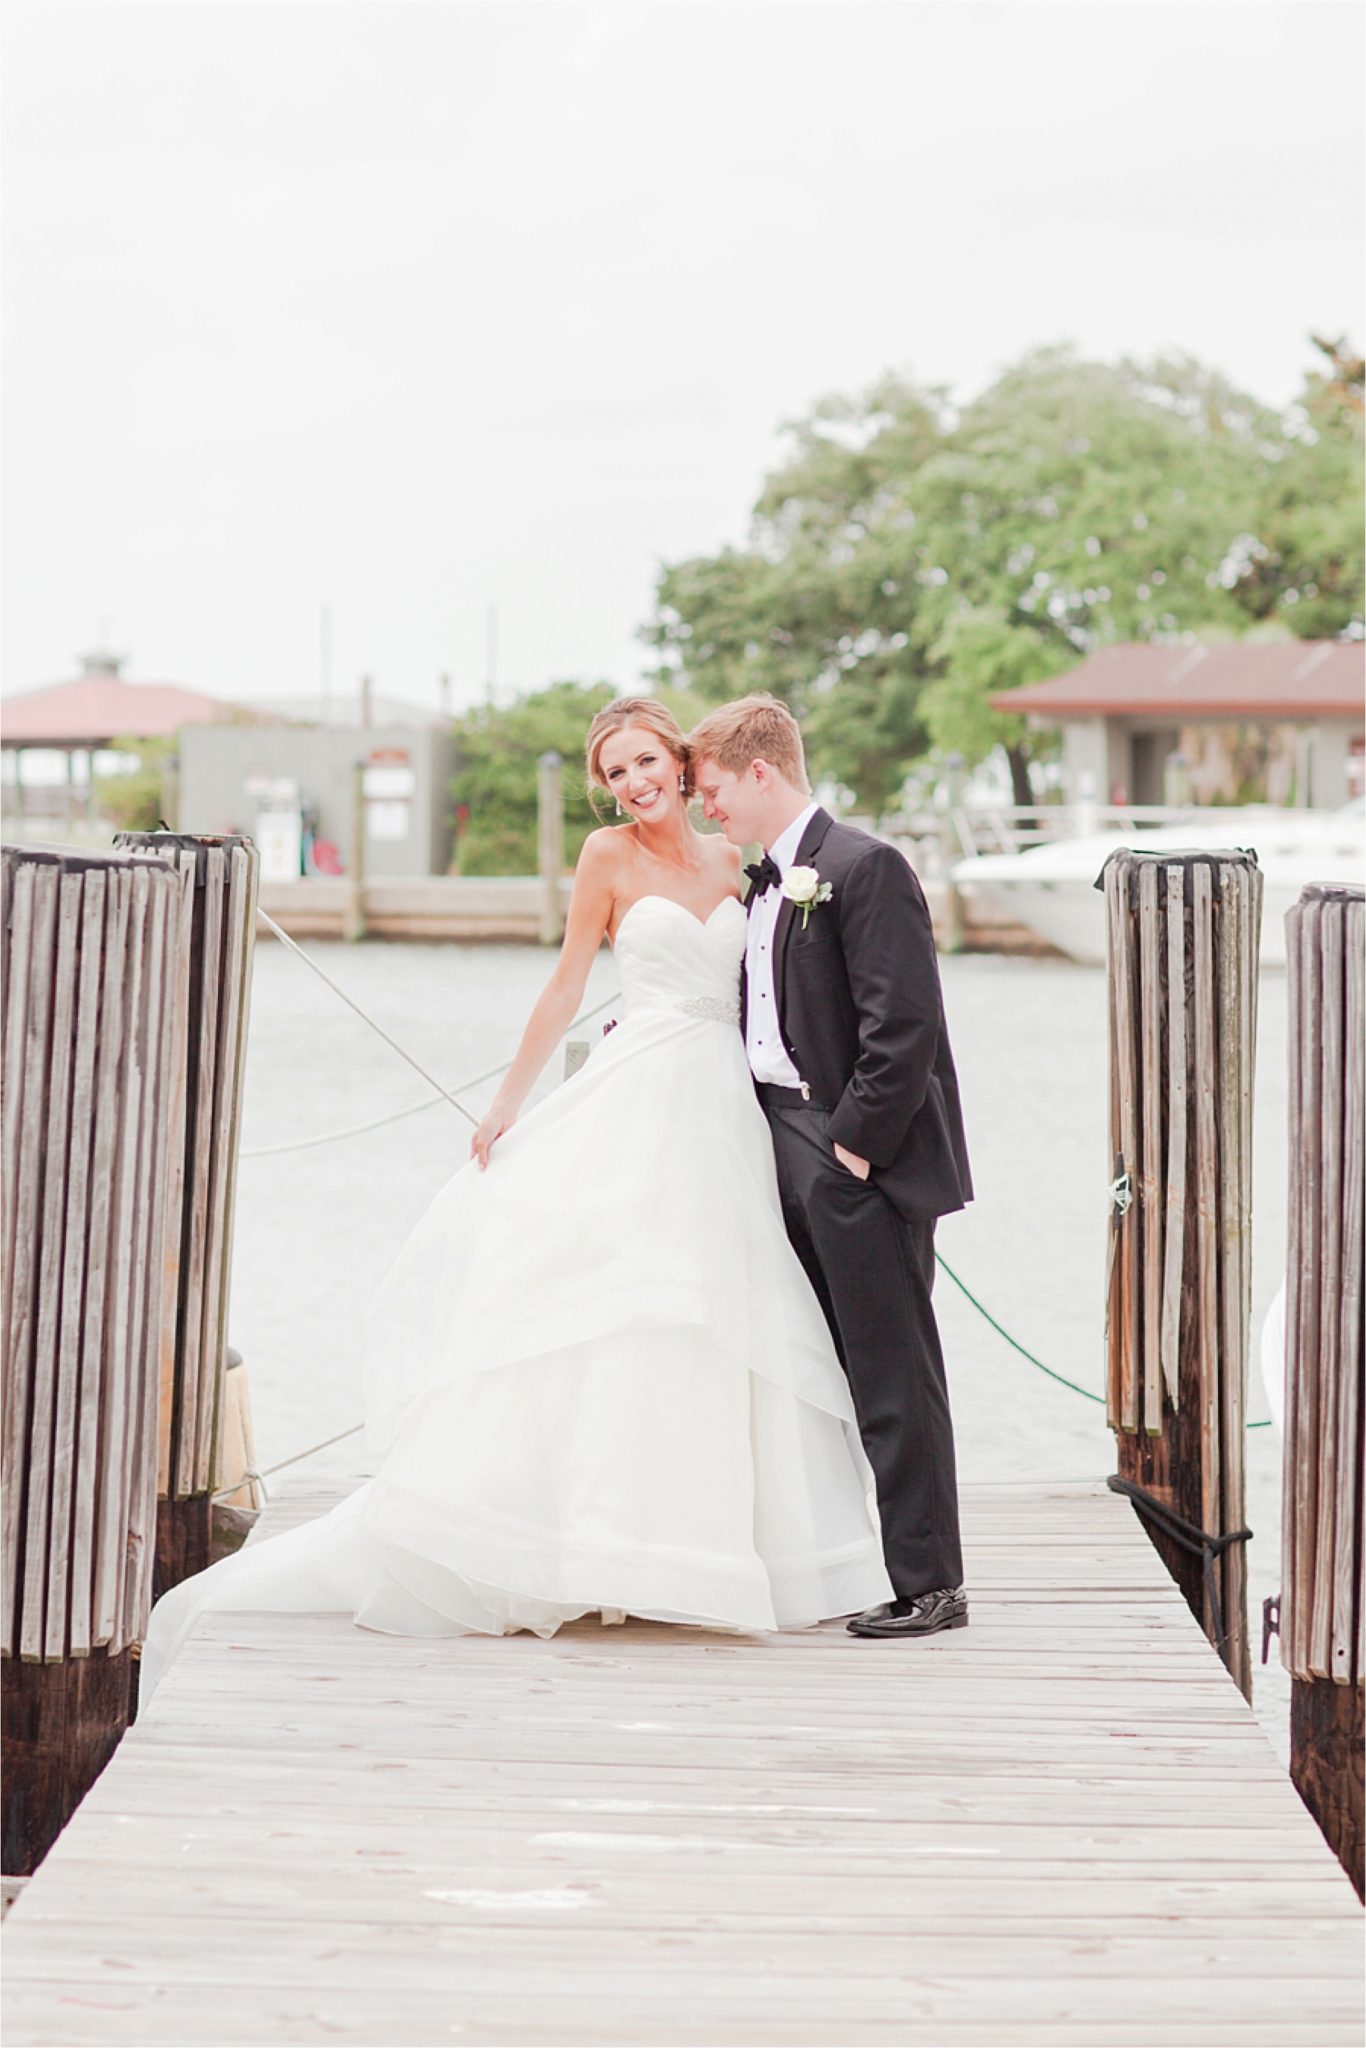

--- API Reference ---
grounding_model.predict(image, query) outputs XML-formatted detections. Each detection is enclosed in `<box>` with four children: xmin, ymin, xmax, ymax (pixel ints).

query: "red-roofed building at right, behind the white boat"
<box><xmin>991</xmin><ymin>641</ymin><xmax>1366</xmax><ymax>809</ymax></box>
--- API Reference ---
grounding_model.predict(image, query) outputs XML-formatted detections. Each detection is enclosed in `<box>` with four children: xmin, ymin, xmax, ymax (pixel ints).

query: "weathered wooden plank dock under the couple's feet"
<box><xmin>4</xmin><ymin>1483</ymin><xmax>1362</xmax><ymax>2048</ymax></box>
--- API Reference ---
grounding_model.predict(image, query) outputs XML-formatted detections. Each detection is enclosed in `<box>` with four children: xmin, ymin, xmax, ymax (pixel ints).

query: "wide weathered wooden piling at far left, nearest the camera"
<box><xmin>0</xmin><ymin>848</ymin><xmax>180</xmax><ymax>1874</ymax></box>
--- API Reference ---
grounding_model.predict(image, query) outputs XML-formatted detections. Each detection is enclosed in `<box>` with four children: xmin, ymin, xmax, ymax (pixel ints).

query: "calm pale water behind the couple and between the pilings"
<box><xmin>231</xmin><ymin>944</ymin><xmax>1288</xmax><ymax>1753</ymax></box>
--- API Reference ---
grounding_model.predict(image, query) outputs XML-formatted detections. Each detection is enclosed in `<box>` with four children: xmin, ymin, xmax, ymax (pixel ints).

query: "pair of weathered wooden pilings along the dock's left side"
<box><xmin>0</xmin><ymin>834</ymin><xmax>256</xmax><ymax>1874</ymax></box>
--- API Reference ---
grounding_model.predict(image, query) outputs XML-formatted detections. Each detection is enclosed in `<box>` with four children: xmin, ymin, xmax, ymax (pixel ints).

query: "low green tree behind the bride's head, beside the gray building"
<box><xmin>451</xmin><ymin>682</ymin><xmax>700</xmax><ymax>874</ymax></box>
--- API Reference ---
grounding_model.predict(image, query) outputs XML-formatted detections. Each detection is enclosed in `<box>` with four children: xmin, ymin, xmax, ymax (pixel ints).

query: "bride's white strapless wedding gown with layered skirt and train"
<box><xmin>141</xmin><ymin>895</ymin><xmax>891</xmax><ymax>1698</ymax></box>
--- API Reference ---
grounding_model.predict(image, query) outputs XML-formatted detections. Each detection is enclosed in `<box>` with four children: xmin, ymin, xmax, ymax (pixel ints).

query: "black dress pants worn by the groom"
<box><xmin>764</xmin><ymin>1102</ymin><xmax>963</xmax><ymax>1599</ymax></box>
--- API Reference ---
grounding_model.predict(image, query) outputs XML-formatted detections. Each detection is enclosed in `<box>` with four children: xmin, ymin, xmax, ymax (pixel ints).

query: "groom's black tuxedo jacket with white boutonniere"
<box><xmin>741</xmin><ymin>811</ymin><xmax>973</xmax><ymax>1223</ymax></box>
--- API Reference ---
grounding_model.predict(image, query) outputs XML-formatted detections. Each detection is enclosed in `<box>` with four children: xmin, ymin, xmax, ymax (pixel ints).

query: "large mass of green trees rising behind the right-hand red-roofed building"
<box><xmin>647</xmin><ymin>348</ymin><xmax>1360</xmax><ymax>811</ymax></box>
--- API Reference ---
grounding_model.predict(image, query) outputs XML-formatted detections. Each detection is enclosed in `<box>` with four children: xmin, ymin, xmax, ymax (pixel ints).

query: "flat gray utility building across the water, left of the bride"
<box><xmin>178</xmin><ymin>700</ymin><xmax>455</xmax><ymax>881</ymax></box>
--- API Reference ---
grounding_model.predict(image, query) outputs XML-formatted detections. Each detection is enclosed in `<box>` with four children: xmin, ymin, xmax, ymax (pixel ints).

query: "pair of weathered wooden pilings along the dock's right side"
<box><xmin>1100</xmin><ymin>848</ymin><xmax>1366</xmax><ymax>1892</ymax></box>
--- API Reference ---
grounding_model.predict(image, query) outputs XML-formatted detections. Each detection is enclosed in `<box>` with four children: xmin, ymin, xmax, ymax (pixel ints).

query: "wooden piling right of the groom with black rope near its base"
<box><xmin>1102</xmin><ymin>848</ymin><xmax>1262</xmax><ymax>1694</ymax></box>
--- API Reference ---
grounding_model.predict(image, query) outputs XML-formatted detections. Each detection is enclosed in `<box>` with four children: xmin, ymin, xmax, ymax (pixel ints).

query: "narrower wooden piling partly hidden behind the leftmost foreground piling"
<box><xmin>117</xmin><ymin>831</ymin><xmax>258</xmax><ymax>1593</ymax></box>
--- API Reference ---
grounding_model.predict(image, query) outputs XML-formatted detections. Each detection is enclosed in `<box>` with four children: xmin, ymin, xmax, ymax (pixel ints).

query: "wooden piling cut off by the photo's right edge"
<box><xmin>1280</xmin><ymin>883</ymin><xmax>1366</xmax><ymax>1892</ymax></box>
